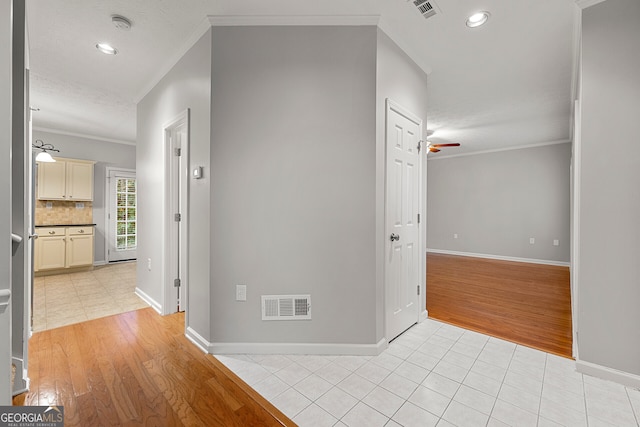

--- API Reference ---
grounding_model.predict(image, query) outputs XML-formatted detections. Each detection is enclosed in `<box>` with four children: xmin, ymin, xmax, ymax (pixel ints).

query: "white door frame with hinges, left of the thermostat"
<box><xmin>162</xmin><ymin>109</ymin><xmax>190</xmax><ymax>315</ymax></box>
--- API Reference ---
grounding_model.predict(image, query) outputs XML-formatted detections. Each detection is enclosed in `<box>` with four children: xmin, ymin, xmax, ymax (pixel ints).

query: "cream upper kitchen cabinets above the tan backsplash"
<box><xmin>37</xmin><ymin>157</ymin><xmax>95</xmax><ymax>201</ymax></box>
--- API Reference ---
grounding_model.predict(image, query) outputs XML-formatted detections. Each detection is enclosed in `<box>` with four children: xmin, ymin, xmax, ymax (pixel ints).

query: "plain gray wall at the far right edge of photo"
<box><xmin>578</xmin><ymin>0</ymin><xmax>640</xmax><ymax>375</ymax></box>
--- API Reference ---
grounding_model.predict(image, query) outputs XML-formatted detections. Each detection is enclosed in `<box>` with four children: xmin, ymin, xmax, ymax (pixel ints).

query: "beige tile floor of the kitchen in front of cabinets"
<box><xmin>33</xmin><ymin>262</ymin><xmax>148</xmax><ymax>332</ymax></box>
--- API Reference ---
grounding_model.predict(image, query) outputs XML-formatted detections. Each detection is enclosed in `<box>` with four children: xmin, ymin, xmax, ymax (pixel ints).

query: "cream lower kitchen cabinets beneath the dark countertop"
<box><xmin>34</xmin><ymin>226</ymin><xmax>93</xmax><ymax>271</ymax></box>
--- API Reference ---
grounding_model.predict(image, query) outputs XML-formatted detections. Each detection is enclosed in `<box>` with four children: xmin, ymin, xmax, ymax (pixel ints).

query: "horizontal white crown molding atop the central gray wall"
<box><xmin>207</xmin><ymin>15</ymin><xmax>380</xmax><ymax>27</ymax></box>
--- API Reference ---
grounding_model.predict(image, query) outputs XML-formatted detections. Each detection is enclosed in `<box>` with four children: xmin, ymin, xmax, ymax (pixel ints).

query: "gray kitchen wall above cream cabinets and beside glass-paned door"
<box><xmin>33</xmin><ymin>130</ymin><xmax>136</xmax><ymax>263</ymax></box>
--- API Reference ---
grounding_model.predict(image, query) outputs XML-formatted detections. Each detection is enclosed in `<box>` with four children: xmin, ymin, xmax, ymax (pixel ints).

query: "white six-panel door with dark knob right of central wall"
<box><xmin>385</xmin><ymin>100</ymin><xmax>424</xmax><ymax>340</ymax></box>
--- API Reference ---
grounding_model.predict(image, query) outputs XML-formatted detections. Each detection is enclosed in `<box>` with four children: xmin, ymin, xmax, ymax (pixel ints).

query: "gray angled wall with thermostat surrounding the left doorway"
<box><xmin>136</xmin><ymin>31</ymin><xmax>211</xmax><ymax>340</ymax></box>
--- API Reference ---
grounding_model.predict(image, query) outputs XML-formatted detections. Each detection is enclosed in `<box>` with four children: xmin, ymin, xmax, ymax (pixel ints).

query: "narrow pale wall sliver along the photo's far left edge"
<box><xmin>0</xmin><ymin>1</ymin><xmax>13</xmax><ymax>405</ymax></box>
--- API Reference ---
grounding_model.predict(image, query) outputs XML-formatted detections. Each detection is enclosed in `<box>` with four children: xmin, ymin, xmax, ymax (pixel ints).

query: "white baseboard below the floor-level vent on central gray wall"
<box><xmin>208</xmin><ymin>338</ymin><xmax>389</xmax><ymax>356</ymax></box>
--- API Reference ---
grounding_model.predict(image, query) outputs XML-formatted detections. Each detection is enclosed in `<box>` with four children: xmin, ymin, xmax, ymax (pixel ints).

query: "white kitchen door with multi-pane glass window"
<box><xmin>107</xmin><ymin>169</ymin><xmax>138</xmax><ymax>262</ymax></box>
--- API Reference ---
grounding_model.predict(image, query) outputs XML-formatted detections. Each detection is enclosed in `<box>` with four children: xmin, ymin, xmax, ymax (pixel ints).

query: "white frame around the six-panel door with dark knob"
<box><xmin>383</xmin><ymin>98</ymin><xmax>427</xmax><ymax>341</ymax></box>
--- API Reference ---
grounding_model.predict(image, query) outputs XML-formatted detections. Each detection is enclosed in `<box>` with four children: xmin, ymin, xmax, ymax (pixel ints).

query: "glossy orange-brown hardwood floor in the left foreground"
<box><xmin>14</xmin><ymin>308</ymin><xmax>295</xmax><ymax>427</ymax></box>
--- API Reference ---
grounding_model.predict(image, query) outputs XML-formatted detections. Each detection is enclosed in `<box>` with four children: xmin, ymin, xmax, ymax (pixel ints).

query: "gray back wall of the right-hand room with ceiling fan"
<box><xmin>427</xmin><ymin>143</ymin><xmax>571</xmax><ymax>263</ymax></box>
